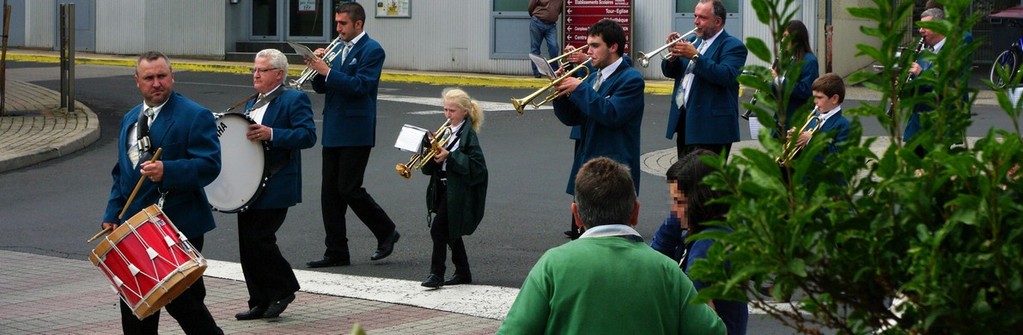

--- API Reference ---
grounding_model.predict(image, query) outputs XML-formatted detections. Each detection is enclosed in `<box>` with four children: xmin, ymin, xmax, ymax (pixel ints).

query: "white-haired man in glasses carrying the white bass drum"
<box><xmin>234</xmin><ymin>49</ymin><xmax>316</xmax><ymax>320</ymax></box>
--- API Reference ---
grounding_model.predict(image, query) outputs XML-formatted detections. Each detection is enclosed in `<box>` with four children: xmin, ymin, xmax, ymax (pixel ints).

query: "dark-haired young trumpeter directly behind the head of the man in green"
<box><xmin>553</xmin><ymin>19</ymin><xmax>647</xmax><ymax>200</ymax></box>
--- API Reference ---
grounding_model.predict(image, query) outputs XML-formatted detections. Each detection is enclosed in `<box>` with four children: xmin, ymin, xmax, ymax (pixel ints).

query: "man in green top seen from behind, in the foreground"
<box><xmin>497</xmin><ymin>157</ymin><xmax>725</xmax><ymax>334</ymax></box>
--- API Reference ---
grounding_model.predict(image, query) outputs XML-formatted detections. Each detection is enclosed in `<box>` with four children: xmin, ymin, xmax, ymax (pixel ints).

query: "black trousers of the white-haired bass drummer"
<box><xmin>238</xmin><ymin>208</ymin><xmax>299</xmax><ymax>308</ymax></box>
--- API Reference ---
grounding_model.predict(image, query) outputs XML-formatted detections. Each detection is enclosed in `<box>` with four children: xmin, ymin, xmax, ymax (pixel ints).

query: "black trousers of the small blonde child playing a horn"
<box><xmin>430</xmin><ymin>182</ymin><xmax>470</xmax><ymax>278</ymax></box>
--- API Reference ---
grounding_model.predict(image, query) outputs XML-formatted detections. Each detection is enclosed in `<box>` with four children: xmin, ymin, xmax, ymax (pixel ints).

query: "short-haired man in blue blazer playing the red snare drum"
<box><xmin>102</xmin><ymin>51</ymin><xmax>223</xmax><ymax>334</ymax></box>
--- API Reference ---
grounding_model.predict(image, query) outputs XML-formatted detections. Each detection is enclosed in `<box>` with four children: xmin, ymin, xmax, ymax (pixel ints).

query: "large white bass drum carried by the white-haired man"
<box><xmin>206</xmin><ymin>113</ymin><xmax>270</xmax><ymax>213</ymax></box>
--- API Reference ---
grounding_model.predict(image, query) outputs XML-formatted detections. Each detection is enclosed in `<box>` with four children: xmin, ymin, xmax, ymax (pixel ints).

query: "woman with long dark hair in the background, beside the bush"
<box><xmin>771</xmin><ymin>19</ymin><xmax>820</xmax><ymax>133</ymax></box>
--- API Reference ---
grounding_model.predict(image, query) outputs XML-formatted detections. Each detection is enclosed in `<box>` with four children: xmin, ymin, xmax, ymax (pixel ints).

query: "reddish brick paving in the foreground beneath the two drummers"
<box><xmin>0</xmin><ymin>251</ymin><xmax>510</xmax><ymax>335</ymax></box>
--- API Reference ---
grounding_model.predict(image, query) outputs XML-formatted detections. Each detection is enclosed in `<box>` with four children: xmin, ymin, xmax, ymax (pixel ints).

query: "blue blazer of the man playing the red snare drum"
<box><xmin>103</xmin><ymin>92</ymin><xmax>220</xmax><ymax>238</ymax></box>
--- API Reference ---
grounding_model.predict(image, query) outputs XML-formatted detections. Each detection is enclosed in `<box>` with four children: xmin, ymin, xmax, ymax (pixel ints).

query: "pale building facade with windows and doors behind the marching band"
<box><xmin>9</xmin><ymin>0</ymin><xmax>1010</xmax><ymax>79</ymax></box>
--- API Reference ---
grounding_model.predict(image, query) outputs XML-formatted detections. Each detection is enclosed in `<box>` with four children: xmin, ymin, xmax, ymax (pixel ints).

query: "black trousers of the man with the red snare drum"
<box><xmin>120</xmin><ymin>236</ymin><xmax>224</xmax><ymax>335</ymax></box>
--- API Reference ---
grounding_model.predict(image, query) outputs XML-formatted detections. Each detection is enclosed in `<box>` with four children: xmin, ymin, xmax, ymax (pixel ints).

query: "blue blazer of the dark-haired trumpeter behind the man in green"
<box><xmin>553</xmin><ymin>59</ymin><xmax>647</xmax><ymax>195</ymax></box>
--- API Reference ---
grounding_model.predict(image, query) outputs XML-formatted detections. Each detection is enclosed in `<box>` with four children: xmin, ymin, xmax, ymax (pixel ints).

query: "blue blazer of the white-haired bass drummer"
<box><xmin>246</xmin><ymin>86</ymin><xmax>316</xmax><ymax>209</ymax></box>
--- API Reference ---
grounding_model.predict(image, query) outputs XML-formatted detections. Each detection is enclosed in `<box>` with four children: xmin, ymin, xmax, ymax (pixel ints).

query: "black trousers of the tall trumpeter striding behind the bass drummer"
<box><xmin>320</xmin><ymin>146</ymin><xmax>395</xmax><ymax>260</ymax></box>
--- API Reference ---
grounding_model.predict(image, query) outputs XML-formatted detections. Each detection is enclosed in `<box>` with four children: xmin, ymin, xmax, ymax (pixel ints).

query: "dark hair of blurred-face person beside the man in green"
<box><xmin>675</xmin><ymin>149</ymin><xmax>728</xmax><ymax>234</ymax></box>
